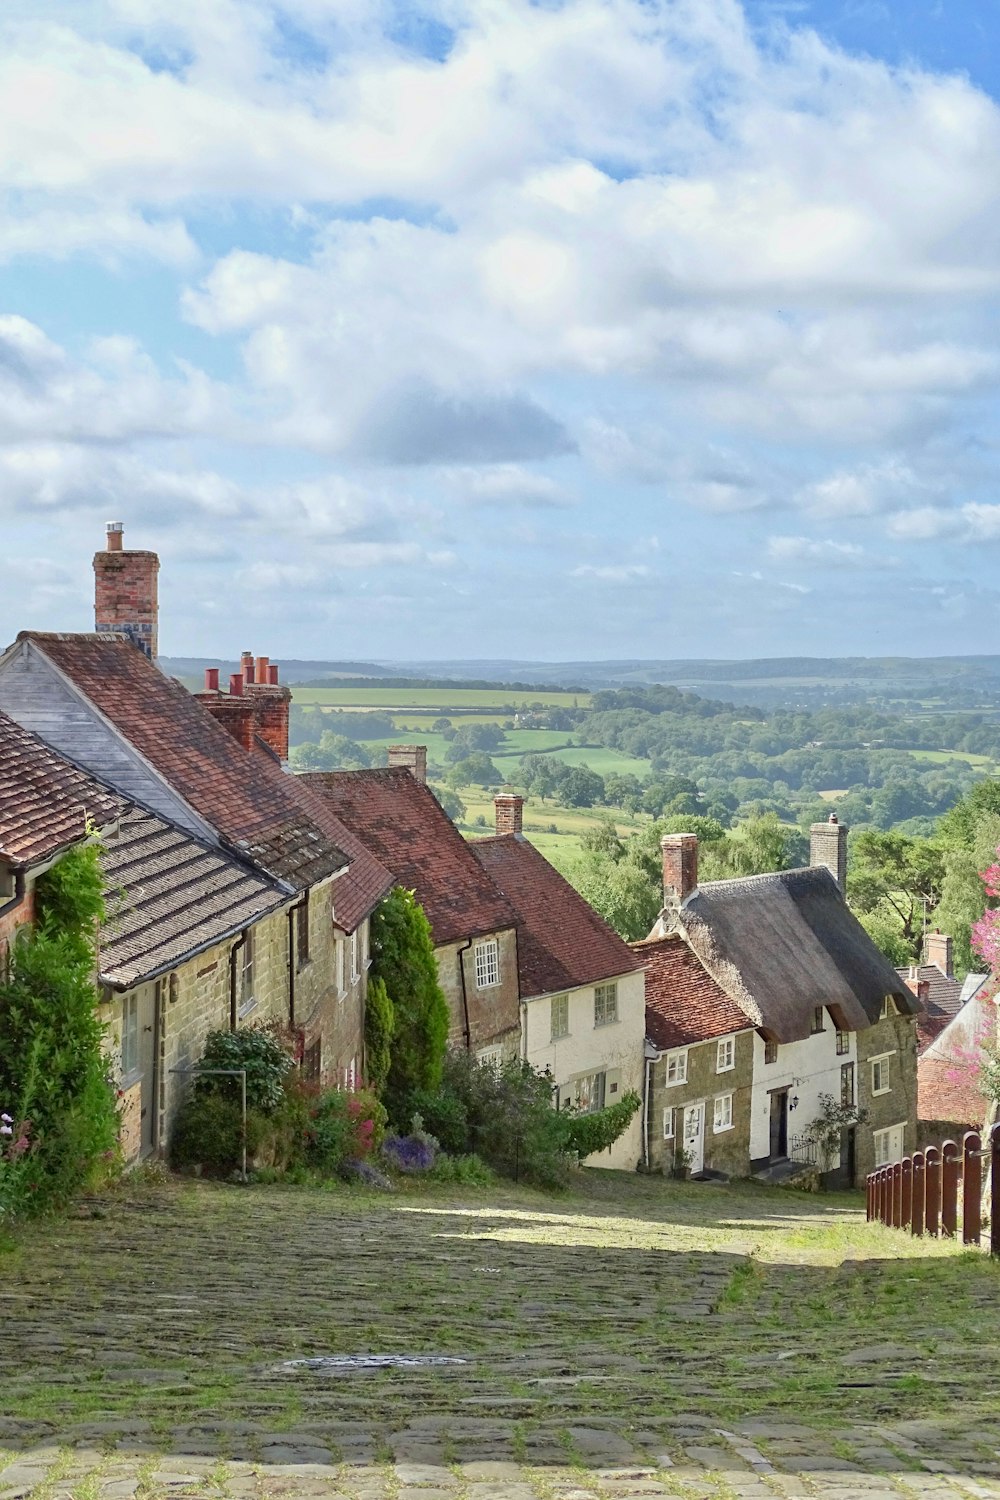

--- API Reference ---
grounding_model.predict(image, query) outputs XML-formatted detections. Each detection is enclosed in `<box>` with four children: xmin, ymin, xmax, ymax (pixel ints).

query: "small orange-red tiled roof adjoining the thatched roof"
<box><xmin>631</xmin><ymin>933</ymin><xmax>753</xmax><ymax>1052</ymax></box>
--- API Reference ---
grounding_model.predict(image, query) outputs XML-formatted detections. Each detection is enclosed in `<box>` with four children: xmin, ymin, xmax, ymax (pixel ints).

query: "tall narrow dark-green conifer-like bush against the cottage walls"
<box><xmin>369</xmin><ymin>885</ymin><xmax>450</xmax><ymax>1127</ymax></box>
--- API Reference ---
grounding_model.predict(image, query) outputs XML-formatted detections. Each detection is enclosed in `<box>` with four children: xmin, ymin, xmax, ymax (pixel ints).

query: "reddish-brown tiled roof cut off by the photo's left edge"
<box><xmin>0</xmin><ymin>714</ymin><xmax>120</xmax><ymax>870</ymax></box>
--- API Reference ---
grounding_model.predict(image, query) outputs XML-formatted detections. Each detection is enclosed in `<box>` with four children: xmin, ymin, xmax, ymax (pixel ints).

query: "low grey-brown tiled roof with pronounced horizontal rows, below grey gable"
<box><xmin>99</xmin><ymin>807</ymin><xmax>286</xmax><ymax>989</ymax></box>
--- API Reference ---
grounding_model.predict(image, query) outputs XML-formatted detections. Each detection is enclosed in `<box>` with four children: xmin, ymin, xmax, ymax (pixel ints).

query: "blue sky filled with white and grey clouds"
<box><xmin>0</xmin><ymin>0</ymin><xmax>1000</xmax><ymax>659</ymax></box>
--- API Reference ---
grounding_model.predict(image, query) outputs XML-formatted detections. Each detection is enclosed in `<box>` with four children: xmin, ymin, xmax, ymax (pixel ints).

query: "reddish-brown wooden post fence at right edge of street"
<box><xmin>867</xmin><ymin>1121</ymin><xmax>1000</xmax><ymax>1256</ymax></box>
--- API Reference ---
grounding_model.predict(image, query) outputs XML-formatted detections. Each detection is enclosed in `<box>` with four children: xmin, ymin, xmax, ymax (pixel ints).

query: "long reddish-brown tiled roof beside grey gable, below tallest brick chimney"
<box><xmin>18</xmin><ymin>632</ymin><xmax>348</xmax><ymax>891</ymax></box>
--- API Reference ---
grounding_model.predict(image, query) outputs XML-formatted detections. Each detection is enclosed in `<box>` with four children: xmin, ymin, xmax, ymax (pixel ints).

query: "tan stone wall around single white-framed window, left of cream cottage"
<box><xmin>435</xmin><ymin>927</ymin><xmax>520</xmax><ymax>1058</ymax></box>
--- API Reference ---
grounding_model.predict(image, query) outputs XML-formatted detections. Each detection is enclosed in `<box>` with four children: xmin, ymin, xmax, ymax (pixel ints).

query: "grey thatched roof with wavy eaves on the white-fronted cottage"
<box><xmin>678</xmin><ymin>866</ymin><xmax>921</xmax><ymax>1043</ymax></box>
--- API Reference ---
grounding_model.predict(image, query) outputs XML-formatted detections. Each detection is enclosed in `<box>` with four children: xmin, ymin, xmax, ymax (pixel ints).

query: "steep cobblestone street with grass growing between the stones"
<box><xmin>0</xmin><ymin>1173</ymin><xmax>1000</xmax><ymax>1500</ymax></box>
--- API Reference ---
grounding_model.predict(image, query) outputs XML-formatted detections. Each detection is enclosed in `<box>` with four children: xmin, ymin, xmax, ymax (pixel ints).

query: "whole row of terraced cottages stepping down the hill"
<box><xmin>0</xmin><ymin>525</ymin><xmax>919</xmax><ymax>1181</ymax></box>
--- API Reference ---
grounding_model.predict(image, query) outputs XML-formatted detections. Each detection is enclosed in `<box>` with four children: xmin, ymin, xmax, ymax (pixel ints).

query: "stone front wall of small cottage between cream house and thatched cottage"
<box><xmin>648</xmin><ymin>1031</ymin><xmax>756</xmax><ymax>1178</ymax></box>
